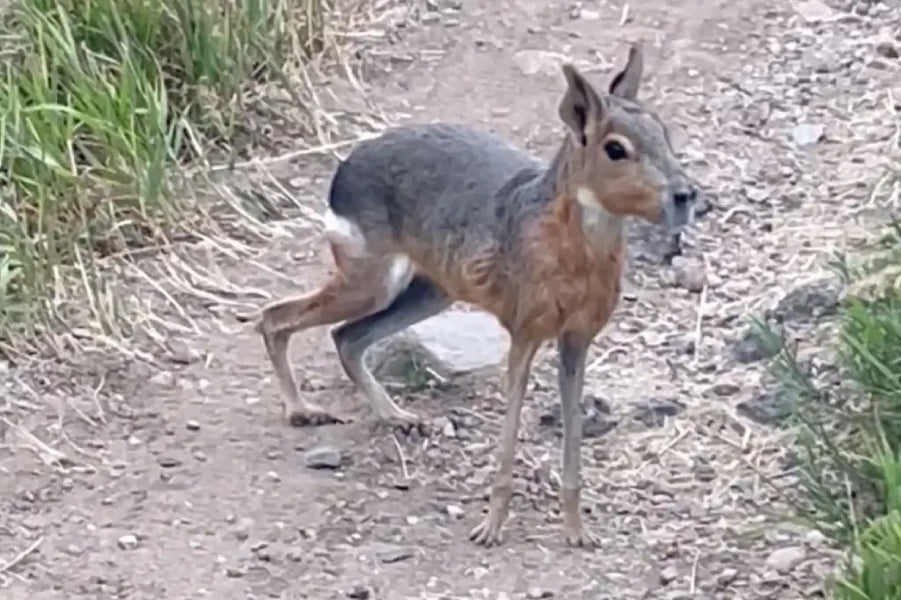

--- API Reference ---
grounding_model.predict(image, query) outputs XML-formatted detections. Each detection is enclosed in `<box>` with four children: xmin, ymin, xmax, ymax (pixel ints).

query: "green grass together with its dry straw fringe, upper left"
<box><xmin>0</xmin><ymin>0</ymin><xmax>406</xmax><ymax>358</ymax></box>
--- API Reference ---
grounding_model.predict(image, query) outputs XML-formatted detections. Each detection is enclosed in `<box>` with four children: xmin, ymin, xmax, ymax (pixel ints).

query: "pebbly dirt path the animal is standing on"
<box><xmin>0</xmin><ymin>0</ymin><xmax>901</xmax><ymax>600</ymax></box>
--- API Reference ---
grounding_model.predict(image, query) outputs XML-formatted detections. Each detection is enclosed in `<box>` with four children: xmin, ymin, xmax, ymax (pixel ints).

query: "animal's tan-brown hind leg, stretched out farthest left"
<box><xmin>256</xmin><ymin>259</ymin><xmax>409</xmax><ymax>426</ymax></box>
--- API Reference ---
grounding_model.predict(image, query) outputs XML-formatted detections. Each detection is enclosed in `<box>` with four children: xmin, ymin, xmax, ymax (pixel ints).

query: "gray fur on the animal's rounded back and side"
<box><xmin>329</xmin><ymin>123</ymin><xmax>554</xmax><ymax>253</ymax></box>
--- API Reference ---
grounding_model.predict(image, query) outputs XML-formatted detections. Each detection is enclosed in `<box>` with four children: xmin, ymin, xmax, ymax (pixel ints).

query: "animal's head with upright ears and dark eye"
<box><xmin>560</xmin><ymin>46</ymin><xmax>697</xmax><ymax>234</ymax></box>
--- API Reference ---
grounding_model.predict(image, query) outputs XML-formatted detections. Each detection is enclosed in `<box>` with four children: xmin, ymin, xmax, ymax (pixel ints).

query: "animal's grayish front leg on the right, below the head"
<box><xmin>557</xmin><ymin>333</ymin><xmax>600</xmax><ymax>548</ymax></box>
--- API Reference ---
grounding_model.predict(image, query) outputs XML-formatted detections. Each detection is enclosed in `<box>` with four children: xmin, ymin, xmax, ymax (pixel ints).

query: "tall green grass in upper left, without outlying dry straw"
<box><xmin>0</xmin><ymin>0</ymin><xmax>326</xmax><ymax>352</ymax></box>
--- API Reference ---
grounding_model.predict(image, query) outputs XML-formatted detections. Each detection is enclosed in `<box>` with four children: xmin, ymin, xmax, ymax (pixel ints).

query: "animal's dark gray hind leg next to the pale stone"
<box><xmin>332</xmin><ymin>275</ymin><xmax>451</xmax><ymax>429</ymax></box>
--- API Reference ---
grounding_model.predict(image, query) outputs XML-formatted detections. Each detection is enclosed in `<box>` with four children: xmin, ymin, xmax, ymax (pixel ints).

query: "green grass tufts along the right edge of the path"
<box><xmin>765</xmin><ymin>217</ymin><xmax>901</xmax><ymax>600</ymax></box>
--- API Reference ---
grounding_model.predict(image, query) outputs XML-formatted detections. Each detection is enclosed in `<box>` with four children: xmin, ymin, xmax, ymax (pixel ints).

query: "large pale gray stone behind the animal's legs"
<box><xmin>367</xmin><ymin>309</ymin><xmax>510</xmax><ymax>377</ymax></box>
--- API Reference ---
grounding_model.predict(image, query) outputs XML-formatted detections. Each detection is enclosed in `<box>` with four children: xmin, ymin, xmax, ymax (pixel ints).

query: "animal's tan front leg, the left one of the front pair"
<box><xmin>469</xmin><ymin>335</ymin><xmax>538</xmax><ymax>547</ymax></box>
